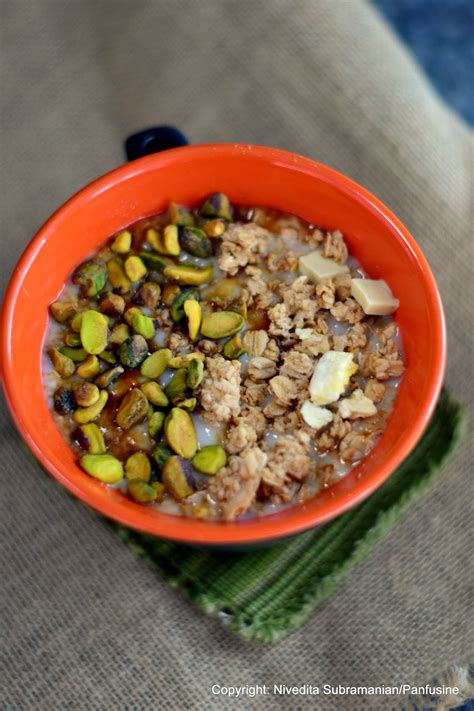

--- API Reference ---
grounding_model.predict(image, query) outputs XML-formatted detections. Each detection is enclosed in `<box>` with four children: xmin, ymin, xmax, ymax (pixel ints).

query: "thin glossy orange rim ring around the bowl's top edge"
<box><xmin>0</xmin><ymin>143</ymin><xmax>447</xmax><ymax>546</ymax></box>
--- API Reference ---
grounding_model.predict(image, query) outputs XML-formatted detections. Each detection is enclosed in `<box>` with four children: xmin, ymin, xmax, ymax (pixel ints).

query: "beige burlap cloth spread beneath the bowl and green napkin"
<box><xmin>0</xmin><ymin>0</ymin><xmax>474</xmax><ymax>711</ymax></box>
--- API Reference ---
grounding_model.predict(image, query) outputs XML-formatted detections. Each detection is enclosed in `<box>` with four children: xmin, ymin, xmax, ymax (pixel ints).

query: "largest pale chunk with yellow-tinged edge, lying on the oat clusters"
<box><xmin>309</xmin><ymin>351</ymin><xmax>359</xmax><ymax>405</ymax></box>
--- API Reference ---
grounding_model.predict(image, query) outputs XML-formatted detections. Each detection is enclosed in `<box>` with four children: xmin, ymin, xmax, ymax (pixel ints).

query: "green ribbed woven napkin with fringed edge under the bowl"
<box><xmin>116</xmin><ymin>392</ymin><xmax>465</xmax><ymax>642</ymax></box>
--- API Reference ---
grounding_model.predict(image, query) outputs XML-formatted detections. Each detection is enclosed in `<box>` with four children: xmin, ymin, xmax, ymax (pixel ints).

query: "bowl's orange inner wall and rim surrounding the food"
<box><xmin>1</xmin><ymin>144</ymin><xmax>446</xmax><ymax>546</ymax></box>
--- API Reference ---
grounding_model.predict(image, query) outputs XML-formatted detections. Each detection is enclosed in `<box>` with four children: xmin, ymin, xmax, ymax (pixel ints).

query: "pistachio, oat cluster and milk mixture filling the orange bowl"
<box><xmin>44</xmin><ymin>193</ymin><xmax>405</xmax><ymax>521</ymax></box>
